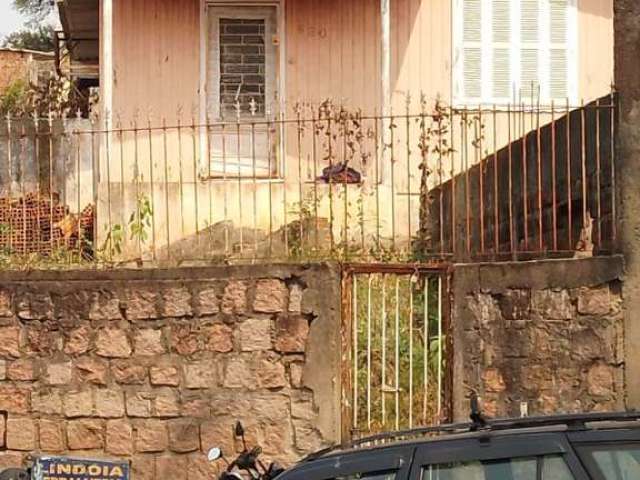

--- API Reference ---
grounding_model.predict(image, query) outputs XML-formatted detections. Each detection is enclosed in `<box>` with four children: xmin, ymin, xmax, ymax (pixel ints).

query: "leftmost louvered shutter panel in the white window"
<box><xmin>462</xmin><ymin>0</ymin><xmax>482</xmax><ymax>99</ymax></box>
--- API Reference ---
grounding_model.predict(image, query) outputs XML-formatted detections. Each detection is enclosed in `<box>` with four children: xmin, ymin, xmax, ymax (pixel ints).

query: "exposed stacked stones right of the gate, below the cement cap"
<box><xmin>460</xmin><ymin>281</ymin><xmax>624</xmax><ymax>417</ymax></box>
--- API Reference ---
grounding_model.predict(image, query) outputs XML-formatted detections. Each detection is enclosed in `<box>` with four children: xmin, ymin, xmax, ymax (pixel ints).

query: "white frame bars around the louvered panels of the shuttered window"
<box><xmin>451</xmin><ymin>0</ymin><xmax>580</xmax><ymax>107</ymax></box>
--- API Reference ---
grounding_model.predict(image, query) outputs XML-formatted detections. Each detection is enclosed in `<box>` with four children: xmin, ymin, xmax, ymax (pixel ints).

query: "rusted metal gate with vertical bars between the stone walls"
<box><xmin>342</xmin><ymin>265</ymin><xmax>452</xmax><ymax>440</ymax></box>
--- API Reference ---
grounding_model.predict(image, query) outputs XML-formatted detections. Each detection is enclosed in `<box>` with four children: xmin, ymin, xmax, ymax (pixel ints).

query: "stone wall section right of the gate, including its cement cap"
<box><xmin>452</xmin><ymin>257</ymin><xmax>625</xmax><ymax>419</ymax></box>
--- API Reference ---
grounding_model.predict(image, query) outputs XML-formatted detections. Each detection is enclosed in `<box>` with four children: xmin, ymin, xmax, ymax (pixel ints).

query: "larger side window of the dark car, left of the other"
<box><xmin>422</xmin><ymin>455</ymin><xmax>574</xmax><ymax>480</ymax></box>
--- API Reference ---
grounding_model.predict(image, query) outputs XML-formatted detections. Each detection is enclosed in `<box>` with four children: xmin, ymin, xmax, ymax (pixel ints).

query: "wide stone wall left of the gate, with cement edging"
<box><xmin>0</xmin><ymin>265</ymin><xmax>340</xmax><ymax>480</ymax></box>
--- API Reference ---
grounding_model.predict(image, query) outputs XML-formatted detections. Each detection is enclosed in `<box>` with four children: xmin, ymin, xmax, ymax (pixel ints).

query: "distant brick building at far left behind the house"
<box><xmin>0</xmin><ymin>48</ymin><xmax>54</xmax><ymax>93</ymax></box>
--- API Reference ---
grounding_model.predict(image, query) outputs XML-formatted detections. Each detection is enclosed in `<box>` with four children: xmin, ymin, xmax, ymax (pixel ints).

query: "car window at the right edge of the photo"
<box><xmin>581</xmin><ymin>443</ymin><xmax>640</xmax><ymax>480</ymax></box>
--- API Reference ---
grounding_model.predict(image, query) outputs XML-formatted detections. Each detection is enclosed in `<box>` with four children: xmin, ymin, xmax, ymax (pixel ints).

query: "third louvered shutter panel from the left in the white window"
<box><xmin>520</xmin><ymin>0</ymin><xmax>540</xmax><ymax>99</ymax></box>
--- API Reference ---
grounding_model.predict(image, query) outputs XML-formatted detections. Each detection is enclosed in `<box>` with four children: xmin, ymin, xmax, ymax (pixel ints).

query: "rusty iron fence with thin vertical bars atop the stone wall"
<box><xmin>0</xmin><ymin>93</ymin><xmax>617</xmax><ymax>268</ymax></box>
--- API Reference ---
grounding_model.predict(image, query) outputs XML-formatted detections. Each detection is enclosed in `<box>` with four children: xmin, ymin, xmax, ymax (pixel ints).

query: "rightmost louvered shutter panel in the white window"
<box><xmin>548</xmin><ymin>0</ymin><xmax>569</xmax><ymax>100</ymax></box>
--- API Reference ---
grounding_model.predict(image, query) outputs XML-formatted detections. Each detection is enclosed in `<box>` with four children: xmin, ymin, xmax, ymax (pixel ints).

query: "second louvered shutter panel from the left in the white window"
<box><xmin>491</xmin><ymin>0</ymin><xmax>513</xmax><ymax>102</ymax></box>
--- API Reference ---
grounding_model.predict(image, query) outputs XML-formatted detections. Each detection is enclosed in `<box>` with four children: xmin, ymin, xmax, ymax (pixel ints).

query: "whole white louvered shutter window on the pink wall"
<box><xmin>454</xmin><ymin>0</ymin><xmax>577</xmax><ymax>104</ymax></box>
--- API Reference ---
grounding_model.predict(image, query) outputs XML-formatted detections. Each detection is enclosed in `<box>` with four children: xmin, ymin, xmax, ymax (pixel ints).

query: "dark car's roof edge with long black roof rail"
<box><xmin>300</xmin><ymin>412</ymin><xmax>640</xmax><ymax>464</ymax></box>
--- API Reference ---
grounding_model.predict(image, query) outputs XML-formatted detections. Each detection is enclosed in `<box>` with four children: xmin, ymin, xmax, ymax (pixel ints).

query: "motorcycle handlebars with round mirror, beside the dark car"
<box><xmin>207</xmin><ymin>422</ymin><xmax>284</xmax><ymax>480</ymax></box>
